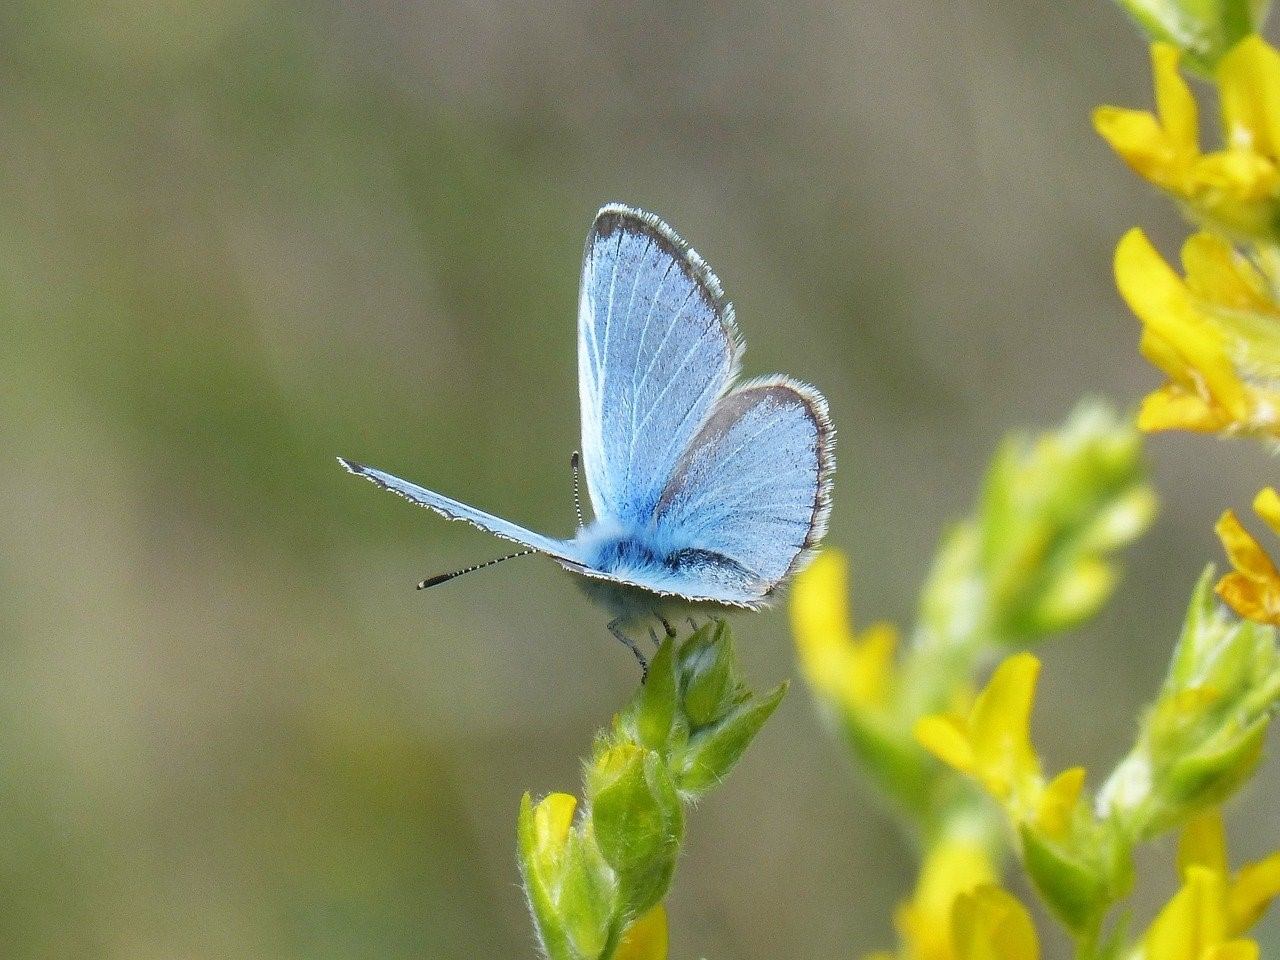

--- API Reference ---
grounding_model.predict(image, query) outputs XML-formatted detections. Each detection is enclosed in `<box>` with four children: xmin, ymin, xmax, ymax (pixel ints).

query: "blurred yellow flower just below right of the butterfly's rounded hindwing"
<box><xmin>791</xmin><ymin>549</ymin><xmax>897</xmax><ymax>709</ymax></box>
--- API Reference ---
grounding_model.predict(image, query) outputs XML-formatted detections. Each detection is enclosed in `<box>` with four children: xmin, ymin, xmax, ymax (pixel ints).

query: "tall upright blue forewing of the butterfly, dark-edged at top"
<box><xmin>579</xmin><ymin>205</ymin><xmax>741</xmax><ymax>522</ymax></box>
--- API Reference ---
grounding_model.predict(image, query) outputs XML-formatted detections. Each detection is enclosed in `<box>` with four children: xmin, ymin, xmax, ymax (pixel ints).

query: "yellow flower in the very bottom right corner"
<box><xmin>1142</xmin><ymin>809</ymin><xmax>1280</xmax><ymax>960</ymax></box>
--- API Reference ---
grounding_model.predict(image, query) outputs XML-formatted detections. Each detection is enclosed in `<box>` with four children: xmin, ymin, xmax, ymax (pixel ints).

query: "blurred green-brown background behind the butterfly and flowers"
<box><xmin>0</xmin><ymin>0</ymin><xmax>1280</xmax><ymax>960</ymax></box>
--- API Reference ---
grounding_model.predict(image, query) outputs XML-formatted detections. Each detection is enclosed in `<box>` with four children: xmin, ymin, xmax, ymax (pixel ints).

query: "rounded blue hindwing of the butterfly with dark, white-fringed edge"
<box><xmin>654</xmin><ymin>378</ymin><xmax>835</xmax><ymax>603</ymax></box>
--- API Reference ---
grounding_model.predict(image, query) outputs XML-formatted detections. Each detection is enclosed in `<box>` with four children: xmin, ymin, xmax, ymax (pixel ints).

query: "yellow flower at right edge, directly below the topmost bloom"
<box><xmin>1115</xmin><ymin>229</ymin><xmax>1280</xmax><ymax>436</ymax></box>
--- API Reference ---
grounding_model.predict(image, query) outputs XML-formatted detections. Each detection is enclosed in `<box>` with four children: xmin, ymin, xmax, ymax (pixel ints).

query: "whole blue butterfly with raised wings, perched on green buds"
<box><xmin>339</xmin><ymin>204</ymin><xmax>835</xmax><ymax>663</ymax></box>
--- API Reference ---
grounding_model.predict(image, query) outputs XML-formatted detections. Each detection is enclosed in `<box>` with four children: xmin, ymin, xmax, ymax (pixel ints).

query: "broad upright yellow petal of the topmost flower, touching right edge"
<box><xmin>1217</xmin><ymin>35</ymin><xmax>1280</xmax><ymax>157</ymax></box>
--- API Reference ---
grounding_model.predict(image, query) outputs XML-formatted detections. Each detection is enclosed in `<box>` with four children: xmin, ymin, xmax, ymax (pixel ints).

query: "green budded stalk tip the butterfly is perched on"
<box><xmin>518</xmin><ymin>621</ymin><xmax>787</xmax><ymax>960</ymax></box>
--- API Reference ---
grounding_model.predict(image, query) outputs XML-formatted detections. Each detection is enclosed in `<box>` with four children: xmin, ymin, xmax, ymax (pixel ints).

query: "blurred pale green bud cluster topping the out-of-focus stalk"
<box><xmin>908</xmin><ymin>403</ymin><xmax>1156</xmax><ymax>660</ymax></box>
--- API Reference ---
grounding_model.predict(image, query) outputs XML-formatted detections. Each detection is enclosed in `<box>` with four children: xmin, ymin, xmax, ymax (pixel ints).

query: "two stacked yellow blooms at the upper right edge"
<box><xmin>1094</xmin><ymin>35</ymin><xmax>1280</xmax><ymax>438</ymax></box>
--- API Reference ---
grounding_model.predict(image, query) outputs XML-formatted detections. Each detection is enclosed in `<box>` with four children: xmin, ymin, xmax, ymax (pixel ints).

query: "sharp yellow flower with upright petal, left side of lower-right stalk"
<box><xmin>915</xmin><ymin>653</ymin><xmax>1061</xmax><ymax>819</ymax></box>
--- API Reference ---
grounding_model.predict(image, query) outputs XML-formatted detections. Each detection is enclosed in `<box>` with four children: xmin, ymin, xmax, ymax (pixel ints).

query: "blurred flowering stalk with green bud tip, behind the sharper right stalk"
<box><xmin>791</xmin><ymin>404</ymin><xmax>1156</xmax><ymax>960</ymax></box>
